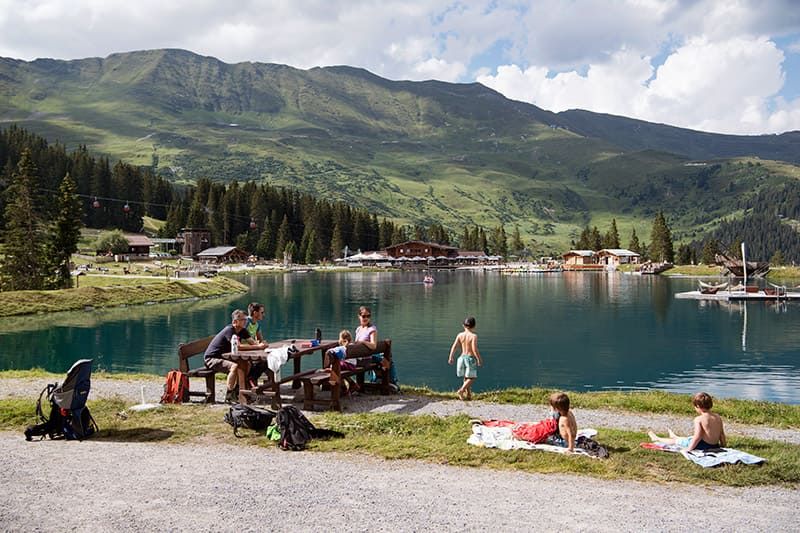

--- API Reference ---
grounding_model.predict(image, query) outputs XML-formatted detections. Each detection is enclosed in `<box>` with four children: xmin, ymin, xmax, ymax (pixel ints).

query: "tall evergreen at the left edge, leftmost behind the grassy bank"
<box><xmin>0</xmin><ymin>149</ymin><xmax>46</xmax><ymax>291</ymax></box>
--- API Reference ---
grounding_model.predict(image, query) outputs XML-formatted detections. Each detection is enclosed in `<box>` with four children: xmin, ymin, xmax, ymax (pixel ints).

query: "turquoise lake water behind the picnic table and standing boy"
<box><xmin>0</xmin><ymin>272</ymin><xmax>800</xmax><ymax>403</ymax></box>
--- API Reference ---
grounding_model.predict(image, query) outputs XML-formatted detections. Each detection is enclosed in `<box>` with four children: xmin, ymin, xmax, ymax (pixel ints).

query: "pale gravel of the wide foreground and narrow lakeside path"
<box><xmin>0</xmin><ymin>379</ymin><xmax>800</xmax><ymax>532</ymax></box>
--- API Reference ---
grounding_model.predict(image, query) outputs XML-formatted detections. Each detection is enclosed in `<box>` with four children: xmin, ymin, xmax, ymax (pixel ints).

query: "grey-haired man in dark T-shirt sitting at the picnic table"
<box><xmin>203</xmin><ymin>309</ymin><xmax>267</xmax><ymax>403</ymax></box>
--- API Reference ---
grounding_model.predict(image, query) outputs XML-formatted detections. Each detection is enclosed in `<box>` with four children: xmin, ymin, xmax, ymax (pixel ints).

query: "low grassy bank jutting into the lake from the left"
<box><xmin>0</xmin><ymin>276</ymin><xmax>248</xmax><ymax>317</ymax></box>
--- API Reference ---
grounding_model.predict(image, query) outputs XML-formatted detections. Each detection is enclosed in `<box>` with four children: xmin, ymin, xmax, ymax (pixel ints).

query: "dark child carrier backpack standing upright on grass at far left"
<box><xmin>25</xmin><ymin>359</ymin><xmax>98</xmax><ymax>440</ymax></box>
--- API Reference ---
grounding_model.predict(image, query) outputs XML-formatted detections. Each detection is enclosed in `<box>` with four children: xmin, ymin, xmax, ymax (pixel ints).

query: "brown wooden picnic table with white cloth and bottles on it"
<box><xmin>221</xmin><ymin>339</ymin><xmax>339</xmax><ymax>407</ymax></box>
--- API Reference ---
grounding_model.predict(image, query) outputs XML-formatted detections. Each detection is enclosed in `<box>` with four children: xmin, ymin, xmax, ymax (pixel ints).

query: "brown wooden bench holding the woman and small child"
<box><xmin>298</xmin><ymin>339</ymin><xmax>392</xmax><ymax>411</ymax></box>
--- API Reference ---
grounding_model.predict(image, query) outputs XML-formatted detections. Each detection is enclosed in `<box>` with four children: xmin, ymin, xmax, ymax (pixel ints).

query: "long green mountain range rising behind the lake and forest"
<box><xmin>0</xmin><ymin>50</ymin><xmax>800</xmax><ymax>251</ymax></box>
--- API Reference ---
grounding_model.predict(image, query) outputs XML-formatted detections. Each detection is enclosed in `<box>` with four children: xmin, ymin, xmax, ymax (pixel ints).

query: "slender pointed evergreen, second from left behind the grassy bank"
<box><xmin>45</xmin><ymin>174</ymin><xmax>82</xmax><ymax>289</ymax></box>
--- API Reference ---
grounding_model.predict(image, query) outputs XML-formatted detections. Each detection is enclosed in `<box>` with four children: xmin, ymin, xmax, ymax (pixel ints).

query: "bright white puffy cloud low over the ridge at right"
<box><xmin>478</xmin><ymin>38</ymin><xmax>800</xmax><ymax>134</ymax></box>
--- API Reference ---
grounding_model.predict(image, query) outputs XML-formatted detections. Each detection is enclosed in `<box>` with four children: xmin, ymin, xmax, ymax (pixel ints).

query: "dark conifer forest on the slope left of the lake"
<box><xmin>0</xmin><ymin>126</ymin><xmax>519</xmax><ymax>288</ymax></box>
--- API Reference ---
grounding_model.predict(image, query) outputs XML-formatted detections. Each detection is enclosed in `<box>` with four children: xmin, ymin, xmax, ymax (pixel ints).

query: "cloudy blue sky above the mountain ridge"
<box><xmin>0</xmin><ymin>0</ymin><xmax>800</xmax><ymax>134</ymax></box>
